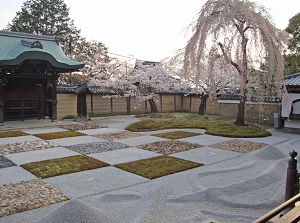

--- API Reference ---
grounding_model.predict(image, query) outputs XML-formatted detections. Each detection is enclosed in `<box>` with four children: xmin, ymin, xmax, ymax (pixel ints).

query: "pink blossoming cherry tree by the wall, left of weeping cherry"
<box><xmin>89</xmin><ymin>60</ymin><xmax>185</xmax><ymax>113</ymax></box>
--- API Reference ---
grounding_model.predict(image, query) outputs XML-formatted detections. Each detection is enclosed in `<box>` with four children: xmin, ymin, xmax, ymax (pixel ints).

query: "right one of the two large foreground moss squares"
<box><xmin>115</xmin><ymin>156</ymin><xmax>203</xmax><ymax>179</ymax></box>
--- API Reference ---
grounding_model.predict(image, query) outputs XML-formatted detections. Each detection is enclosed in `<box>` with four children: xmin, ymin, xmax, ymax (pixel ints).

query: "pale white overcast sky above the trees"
<box><xmin>0</xmin><ymin>0</ymin><xmax>300</xmax><ymax>61</ymax></box>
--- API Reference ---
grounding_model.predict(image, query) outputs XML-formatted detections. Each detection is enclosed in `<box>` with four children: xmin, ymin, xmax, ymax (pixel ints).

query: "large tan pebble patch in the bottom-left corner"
<box><xmin>0</xmin><ymin>180</ymin><xmax>68</xmax><ymax>217</ymax></box>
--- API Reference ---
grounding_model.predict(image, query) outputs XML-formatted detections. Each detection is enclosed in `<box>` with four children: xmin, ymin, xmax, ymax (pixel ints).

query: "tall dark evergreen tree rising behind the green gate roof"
<box><xmin>7</xmin><ymin>0</ymin><xmax>80</xmax><ymax>54</ymax></box>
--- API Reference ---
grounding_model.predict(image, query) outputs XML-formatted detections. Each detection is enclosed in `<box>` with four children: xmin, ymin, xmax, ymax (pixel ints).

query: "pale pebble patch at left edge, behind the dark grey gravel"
<box><xmin>0</xmin><ymin>140</ymin><xmax>58</xmax><ymax>155</ymax></box>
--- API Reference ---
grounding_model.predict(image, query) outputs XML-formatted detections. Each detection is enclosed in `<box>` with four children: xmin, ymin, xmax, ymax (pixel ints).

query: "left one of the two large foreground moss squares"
<box><xmin>21</xmin><ymin>156</ymin><xmax>109</xmax><ymax>179</ymax></box>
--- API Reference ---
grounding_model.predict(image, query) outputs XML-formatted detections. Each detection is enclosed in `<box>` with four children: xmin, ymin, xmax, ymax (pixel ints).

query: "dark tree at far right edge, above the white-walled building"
<box><xmin>284</xmin><ymin>13</ymin><xmax>300</xmax><ymax>75</ymax></box>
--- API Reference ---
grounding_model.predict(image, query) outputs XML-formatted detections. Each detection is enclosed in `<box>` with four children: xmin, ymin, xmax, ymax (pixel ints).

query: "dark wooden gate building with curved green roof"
<box><xmin>0</xmin><ymin>31</ymin><xmax>84</xmax><ymax>123</ymax></box>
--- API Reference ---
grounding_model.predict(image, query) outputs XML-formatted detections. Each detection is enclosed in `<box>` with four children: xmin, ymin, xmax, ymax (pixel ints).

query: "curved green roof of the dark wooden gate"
<box><xmin>0</xmin><ymin>31</ymin><xmax>84</xmax><ymax>72</ymax></box>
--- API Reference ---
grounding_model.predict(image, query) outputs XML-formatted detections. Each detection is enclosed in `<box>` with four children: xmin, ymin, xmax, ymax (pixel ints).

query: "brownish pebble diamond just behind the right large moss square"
<box><xmin>138</xmin><ymin>140</ymin><xmax>201</xmax><ymax>155</ymax></box>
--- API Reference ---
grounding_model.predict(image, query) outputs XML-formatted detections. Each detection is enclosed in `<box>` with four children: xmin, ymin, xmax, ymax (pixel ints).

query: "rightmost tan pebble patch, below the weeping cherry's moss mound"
<box><xmin>210</xmin><ymin>139</ymin><xmax>267</xmax><ymax>153</ymax></box>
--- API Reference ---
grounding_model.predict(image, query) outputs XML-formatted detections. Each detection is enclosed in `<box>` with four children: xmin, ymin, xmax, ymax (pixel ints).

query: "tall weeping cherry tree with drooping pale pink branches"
<box><xmin>184</xmin><ymin>0</ymin><xmax>284</xmax><ymax>125</ymax></box>
